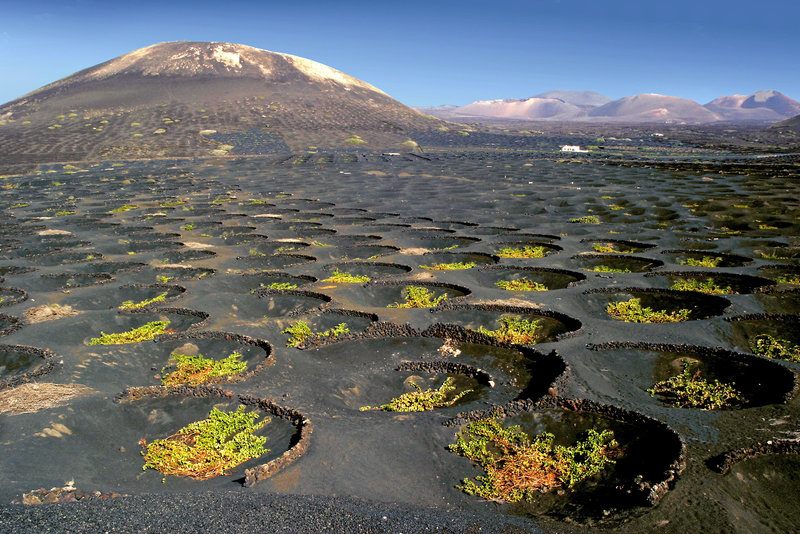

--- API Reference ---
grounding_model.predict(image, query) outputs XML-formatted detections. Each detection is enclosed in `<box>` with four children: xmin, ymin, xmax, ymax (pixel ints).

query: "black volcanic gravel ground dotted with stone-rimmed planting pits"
<box><xmin>0</xmin><ymin>152</ymin><xmax>800</xmax><ymax>532</ymax></box>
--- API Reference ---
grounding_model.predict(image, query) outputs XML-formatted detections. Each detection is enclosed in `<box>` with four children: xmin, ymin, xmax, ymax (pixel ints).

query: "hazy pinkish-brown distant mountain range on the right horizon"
<box><xmin>417</xmin><ymin>91</ymin><xmax>800</xmax><ymax>124</ymax></box>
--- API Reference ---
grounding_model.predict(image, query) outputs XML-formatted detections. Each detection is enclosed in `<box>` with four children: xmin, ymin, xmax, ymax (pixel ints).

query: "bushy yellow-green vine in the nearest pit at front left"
<box><xmin>139</xmin><ymin>406</ymin><xmax>270</xmax><ymax>482</ymax></box>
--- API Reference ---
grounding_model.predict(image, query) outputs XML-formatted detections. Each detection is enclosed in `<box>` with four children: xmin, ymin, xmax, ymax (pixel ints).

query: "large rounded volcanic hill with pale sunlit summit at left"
<box><xmin>0</xmin><ymin>42</ymin><xmax>441</xmax><ymax>163</ymax></box>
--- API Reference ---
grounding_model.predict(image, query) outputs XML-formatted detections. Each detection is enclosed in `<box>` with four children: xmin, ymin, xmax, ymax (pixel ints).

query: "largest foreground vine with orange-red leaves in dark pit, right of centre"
<box><xmin>449</xmin><ymin>418</ymin><xmax>621</xmax><ymax>503</ymax></box>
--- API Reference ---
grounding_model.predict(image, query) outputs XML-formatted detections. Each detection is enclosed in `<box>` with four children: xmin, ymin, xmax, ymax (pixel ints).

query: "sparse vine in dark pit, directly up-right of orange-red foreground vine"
<box><xmin>647</xmin><ymin>360</ymin><xmax>744</xmax><ymax>410</ymax></box>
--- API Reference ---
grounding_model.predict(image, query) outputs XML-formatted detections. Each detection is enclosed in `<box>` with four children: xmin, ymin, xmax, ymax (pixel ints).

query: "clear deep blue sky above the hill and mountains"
<box><xmin>0</xmin><ymin>0</ymin><xmax>800</xmax><ymax>106</ymax></box>
